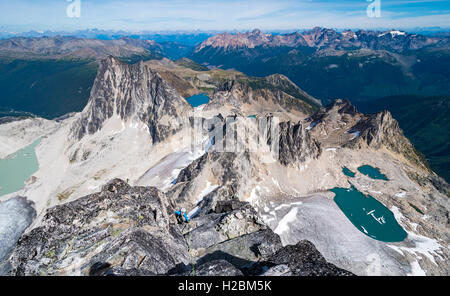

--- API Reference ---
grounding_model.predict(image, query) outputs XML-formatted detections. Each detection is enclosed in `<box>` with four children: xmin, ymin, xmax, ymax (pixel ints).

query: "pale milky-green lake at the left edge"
<box><xmin>0</xmin><ymin>139</ymin><xmax>40</xmax><ymax>196</ymax></box>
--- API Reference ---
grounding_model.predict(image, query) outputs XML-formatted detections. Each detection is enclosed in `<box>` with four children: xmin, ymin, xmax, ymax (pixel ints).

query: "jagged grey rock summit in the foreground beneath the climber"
<box><xmin>5</xmin><ymin>179</ymin><xmax>352</xmax><ymax>276</ymax></box>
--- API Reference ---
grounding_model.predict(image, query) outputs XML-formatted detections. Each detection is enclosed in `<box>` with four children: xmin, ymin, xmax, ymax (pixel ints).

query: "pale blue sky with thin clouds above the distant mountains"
<box><xmin>0</xmin><ymin>0</ymin><xmax>450</xmax><ymax>32</ymax></box>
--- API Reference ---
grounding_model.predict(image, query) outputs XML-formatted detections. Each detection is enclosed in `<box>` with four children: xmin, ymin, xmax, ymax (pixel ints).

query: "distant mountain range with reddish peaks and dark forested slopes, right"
<box><xmin>190</xmin><ymin>28</ymin><xmax>450</xmax><ymax>102</ymax></box>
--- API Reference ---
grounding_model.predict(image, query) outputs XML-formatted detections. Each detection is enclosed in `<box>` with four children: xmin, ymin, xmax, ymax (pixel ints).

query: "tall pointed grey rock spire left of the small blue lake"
<box><xmin>71</xmin><ymin>57</ymin><xmax>191</xmax><ymax>143</ymax></box>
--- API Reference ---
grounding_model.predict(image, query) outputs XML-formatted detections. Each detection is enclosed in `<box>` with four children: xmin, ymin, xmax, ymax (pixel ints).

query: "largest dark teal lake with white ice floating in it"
<box><xmin>331</xmin><ymin>186</ymin><xmax>407</xmax><ymax>242</ymax></box>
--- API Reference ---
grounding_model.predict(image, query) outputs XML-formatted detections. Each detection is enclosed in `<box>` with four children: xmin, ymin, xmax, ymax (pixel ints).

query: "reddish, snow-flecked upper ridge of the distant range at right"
<box><xmin>195</xmin><ymin>27</ymin><xmax>448</xmax><ymax>55</ymax></box>
